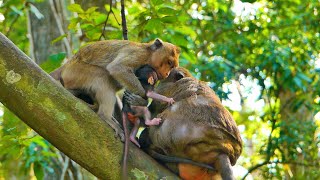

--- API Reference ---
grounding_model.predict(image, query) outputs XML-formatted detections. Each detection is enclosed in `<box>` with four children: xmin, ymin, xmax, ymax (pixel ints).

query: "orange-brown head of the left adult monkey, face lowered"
<box><xmin>150</xmin><ymin>39</ymin><xmax>180</xmax><ymax>79</ymax></box>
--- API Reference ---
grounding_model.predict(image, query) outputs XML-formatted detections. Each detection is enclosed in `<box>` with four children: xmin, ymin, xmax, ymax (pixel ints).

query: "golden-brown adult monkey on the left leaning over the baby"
<box><xmin>51</xmin><ymin>39</ymin><xmax>180</xmax><ymax>139</ymax></box>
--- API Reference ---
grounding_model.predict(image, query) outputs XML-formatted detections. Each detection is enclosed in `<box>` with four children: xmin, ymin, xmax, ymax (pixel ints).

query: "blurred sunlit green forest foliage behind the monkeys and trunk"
<box><xmin>0</xmin><ymin>0</ymin><xmax>320</xmax><ymax>179</ymax></box>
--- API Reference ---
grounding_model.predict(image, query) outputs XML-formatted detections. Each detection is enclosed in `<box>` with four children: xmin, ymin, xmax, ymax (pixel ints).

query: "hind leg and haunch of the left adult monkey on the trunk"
<box><xmin>61</xmin><ymin>61</ymin><xmax>124</xmax><ymax>141</ymax></box>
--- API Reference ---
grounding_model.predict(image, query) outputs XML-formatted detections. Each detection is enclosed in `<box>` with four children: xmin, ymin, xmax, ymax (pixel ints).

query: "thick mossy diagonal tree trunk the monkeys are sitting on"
<box><xmin>0</xmin><ymin>33</ymin><xmax>176</xmax><ymax>179</ymax></box>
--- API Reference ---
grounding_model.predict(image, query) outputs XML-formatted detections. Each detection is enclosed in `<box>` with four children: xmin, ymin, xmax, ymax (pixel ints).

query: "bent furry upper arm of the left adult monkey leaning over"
<box><xmin>107</xmin><ymin>57</ymin><xmax>145</xmax><ymax>97</ymax></box>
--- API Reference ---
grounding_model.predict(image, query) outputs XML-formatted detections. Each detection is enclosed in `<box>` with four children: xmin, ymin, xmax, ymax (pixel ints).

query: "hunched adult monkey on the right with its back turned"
<box><xmin>128</xmin><ymin>68</ymin><xmax>242</xmax><ymax>180</ymax></box>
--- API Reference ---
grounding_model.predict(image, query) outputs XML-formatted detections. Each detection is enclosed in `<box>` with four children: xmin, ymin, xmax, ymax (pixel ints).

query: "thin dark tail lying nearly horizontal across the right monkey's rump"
<box><xmin>150</xmin><ymin>151</ymin><xmax>216</xmax><ymax>171</ymax></box>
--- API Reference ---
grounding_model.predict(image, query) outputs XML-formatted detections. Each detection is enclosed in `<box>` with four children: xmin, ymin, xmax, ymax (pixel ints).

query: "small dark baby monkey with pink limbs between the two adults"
<box><xmin>122</xmin><ymin>65</ymin><xmax>175</xmax><ymax>148</ymax></box>
